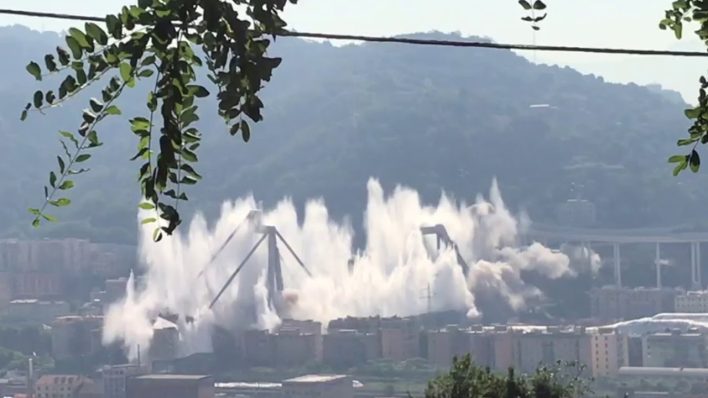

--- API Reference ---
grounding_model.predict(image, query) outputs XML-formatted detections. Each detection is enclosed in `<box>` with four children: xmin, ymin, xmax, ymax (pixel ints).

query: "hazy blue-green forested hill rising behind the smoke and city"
<box><xmin>0</xmin><ymin>27</ymin><xmax>708</xmax><ymax>242</ymax></box>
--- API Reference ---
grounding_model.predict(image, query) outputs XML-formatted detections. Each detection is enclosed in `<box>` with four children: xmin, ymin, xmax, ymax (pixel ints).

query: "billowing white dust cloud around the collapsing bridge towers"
<box><xmin>103</xmin><ymin>179</ymin><xmax>575</xmax><ymax>357</ymax></box>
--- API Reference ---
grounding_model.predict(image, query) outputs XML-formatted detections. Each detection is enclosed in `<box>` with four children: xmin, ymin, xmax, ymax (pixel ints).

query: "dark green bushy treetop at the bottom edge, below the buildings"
<box><xmin>425</xmin><ymin>355</ymin><xmax>590</xmax><ymax>398</ymax></box>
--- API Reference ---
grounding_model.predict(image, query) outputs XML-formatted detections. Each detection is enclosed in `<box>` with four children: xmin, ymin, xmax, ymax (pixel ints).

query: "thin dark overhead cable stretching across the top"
<box><xmin>0</xmin><ymin>8</ymin><xmax>708</xmax><ymax>57</ymax></box>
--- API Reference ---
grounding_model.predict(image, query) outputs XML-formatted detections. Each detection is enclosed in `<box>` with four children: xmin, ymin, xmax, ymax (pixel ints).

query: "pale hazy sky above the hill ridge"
<box><xmin>0</xmin><ymin>0</ymin><xmax>708</xmax><ymax>101</ymax></box>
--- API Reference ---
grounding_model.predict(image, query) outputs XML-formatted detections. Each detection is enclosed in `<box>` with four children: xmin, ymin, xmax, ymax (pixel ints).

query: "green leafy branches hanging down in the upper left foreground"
<box><xmin>21</xmin><ymin>0</ymin><xmax>297</xmax><ymax>240</ymax></box>
